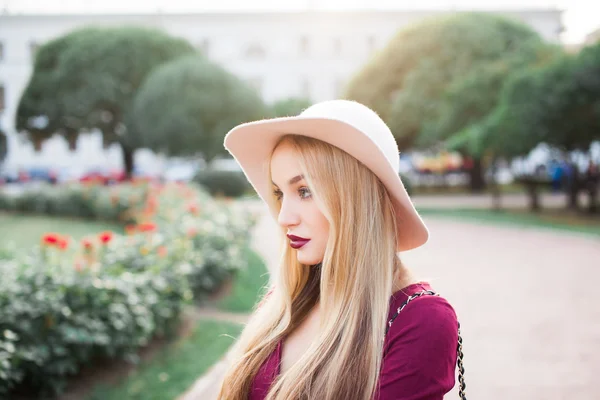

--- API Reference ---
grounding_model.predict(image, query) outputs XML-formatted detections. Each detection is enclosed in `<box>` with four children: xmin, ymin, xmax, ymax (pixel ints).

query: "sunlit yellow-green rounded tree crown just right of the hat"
<box><xmin>345</xmin><ymin>13</ymin><xmax>541</xmax><ymax>148</ymax></box>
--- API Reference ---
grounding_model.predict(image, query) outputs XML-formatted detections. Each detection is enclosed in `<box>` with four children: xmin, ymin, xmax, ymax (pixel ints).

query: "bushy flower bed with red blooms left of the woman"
<box><xmin>0</xmin><ymin>185</ymin><xmax>254</xmax><ymax>395</ymax></box>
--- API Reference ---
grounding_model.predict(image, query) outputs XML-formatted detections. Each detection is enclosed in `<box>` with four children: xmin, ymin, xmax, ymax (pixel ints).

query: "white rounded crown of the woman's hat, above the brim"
<box><xmin>300</xmin><ymin>100</ymin><xmax>400</xmax><ymax>171</ymax></box>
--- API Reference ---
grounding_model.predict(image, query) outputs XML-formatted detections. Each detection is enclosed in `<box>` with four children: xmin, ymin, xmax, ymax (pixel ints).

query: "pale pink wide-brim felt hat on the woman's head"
<box><xmin>224</xmin><ymin>100</ymin><xmax>429</xmax><ymax>251</ymax></box>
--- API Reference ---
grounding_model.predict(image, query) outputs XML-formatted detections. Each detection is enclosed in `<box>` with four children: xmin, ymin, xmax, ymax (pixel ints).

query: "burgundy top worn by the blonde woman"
<box><xmin>249</xmin><ymin>282</ymin><xmax>458</xmax><ymax>400</ymax></box>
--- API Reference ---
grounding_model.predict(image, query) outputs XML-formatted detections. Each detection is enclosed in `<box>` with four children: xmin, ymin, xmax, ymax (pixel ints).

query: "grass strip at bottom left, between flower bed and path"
<box><xmin>87</xmin><ymin>320</ymin><xmax>242</xmax><ymax>400</ymax></box>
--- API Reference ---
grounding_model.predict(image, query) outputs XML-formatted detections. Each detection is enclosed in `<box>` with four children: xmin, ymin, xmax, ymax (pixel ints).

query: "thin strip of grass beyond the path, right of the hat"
<box><xmin>419</xmin><ymin>208</ymin><xmax>600</xmax><ymax>237</ymax></box>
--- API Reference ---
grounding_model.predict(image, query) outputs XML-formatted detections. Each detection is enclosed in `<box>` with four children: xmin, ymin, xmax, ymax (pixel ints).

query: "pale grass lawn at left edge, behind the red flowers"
<box><xmin>0</xmin><ymin>212</ymin><xmax>123</xmax><ymax>247</ymax></box>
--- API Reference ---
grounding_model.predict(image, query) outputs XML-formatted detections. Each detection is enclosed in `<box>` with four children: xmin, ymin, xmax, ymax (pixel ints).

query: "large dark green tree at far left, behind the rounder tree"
<box><xmin>16</xmin><ymin>27</ymin><xmax>195</xmax><ymax>174</ymax></box>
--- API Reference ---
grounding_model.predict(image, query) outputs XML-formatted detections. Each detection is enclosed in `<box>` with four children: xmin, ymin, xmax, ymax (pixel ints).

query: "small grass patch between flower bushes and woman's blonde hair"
<box><xmin>216</xmin><ymin>249</ymin><xmax>269</xmax><ymax>313</ymax></box>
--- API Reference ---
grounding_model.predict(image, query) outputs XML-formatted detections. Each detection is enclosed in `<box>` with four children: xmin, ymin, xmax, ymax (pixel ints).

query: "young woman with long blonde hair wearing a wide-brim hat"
<box><xmin>219</xmin><ymin>100</ymin><xmax>459</xmax><ymax>400</ymax></box>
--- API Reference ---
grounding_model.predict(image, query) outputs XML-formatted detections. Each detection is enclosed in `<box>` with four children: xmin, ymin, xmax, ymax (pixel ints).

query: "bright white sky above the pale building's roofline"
<box><xmin>0</xmin><ymin>0</ymin><xmax>600</xmax><ymax>43</ymax></box>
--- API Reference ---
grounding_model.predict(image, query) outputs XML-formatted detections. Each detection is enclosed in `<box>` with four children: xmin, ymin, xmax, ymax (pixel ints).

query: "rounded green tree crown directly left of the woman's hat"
<box><xmin>132</xmin><ymin>56</ymin><xmax>269</xmax><ymax>162</ymax></box>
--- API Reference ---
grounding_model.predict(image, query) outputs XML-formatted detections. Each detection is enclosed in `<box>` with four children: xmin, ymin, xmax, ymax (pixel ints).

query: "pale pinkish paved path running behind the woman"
<box><xmin>180</xmin><ymin>198</ymin><xmax>600</xmax><ymax>400</ymax></box>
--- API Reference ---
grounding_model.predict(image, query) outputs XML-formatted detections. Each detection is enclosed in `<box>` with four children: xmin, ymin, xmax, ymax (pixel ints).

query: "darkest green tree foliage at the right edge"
<box><xmin>474</xmin><ymin>45</ymin><xmax>600</xmax><ymax>156</ymax></box>
